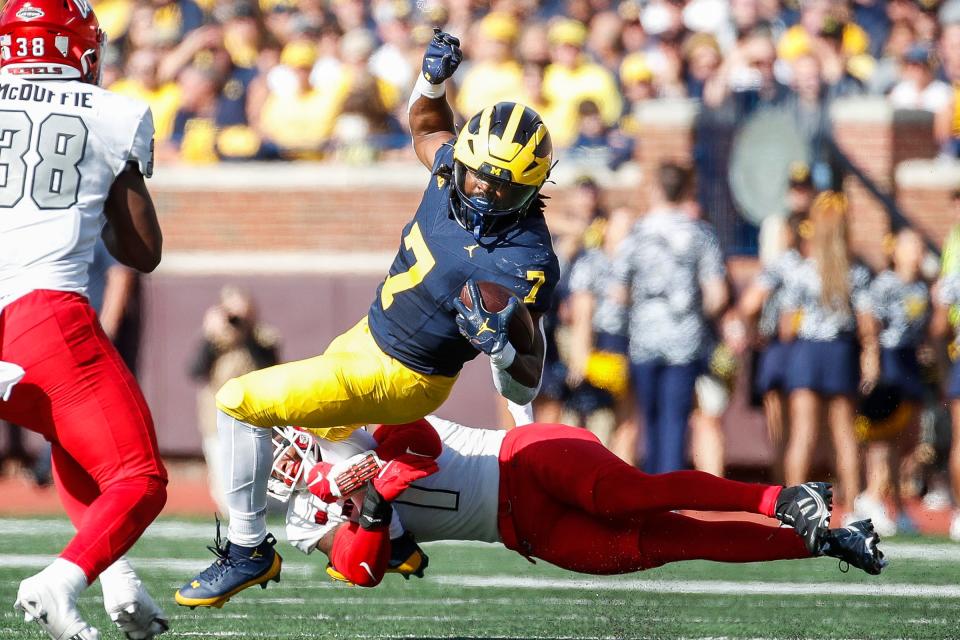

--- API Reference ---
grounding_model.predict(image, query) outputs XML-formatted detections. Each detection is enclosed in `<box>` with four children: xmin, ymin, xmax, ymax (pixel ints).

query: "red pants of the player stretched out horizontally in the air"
<box><xmin>499</xmin><ymin>424</ymin><xmax>810</xmax><ymax>574</ymax></box>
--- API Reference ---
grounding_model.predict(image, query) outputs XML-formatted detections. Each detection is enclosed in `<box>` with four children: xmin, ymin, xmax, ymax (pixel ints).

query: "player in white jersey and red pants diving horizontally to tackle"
<box><xmin>274</xmin><ymin>416</ymin><xmax>886</xmax><ymax>587</ymax></box>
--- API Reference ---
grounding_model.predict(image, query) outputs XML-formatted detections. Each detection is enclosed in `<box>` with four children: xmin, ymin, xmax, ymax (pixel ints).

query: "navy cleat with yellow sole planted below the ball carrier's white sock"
<box><xmin>174</xmin><ymin>522</ymin><xmax>283</xmax><ymax>609</ymax></box>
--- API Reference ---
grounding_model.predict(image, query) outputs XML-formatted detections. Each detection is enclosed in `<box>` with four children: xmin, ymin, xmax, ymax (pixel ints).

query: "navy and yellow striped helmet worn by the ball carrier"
<box><xmin>450</xmin><ymin>102</ymin><xmax>553</xmax><ymax>240</ymax></box>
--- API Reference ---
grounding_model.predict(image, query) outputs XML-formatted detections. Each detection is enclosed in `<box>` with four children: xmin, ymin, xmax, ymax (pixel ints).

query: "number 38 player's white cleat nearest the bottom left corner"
<box><xmin>13</xmin><ymin>575</ymin><xmax>100</xmax><ymax>640</ymax></box>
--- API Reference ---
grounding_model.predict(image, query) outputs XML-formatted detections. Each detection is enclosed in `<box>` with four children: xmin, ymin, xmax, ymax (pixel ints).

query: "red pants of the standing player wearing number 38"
<box><xmin>0</xmin><ymin>290</ymin><xmax>167</xmax><ymax>582</ymax></box>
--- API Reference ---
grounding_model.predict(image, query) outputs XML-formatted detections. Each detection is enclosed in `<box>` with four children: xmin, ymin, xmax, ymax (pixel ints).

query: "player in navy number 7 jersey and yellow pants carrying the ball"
<box><xmin>176</xmin><ymin>30</ymin><xmax>559</xmax><ymax>607</ymax></box>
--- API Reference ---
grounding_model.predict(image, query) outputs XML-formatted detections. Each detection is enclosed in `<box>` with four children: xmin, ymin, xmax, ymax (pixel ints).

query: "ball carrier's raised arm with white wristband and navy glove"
<box><xmin>408</xmin><ymin>29</ymin><xmax>463</xmax><ymax>169</ymax></box>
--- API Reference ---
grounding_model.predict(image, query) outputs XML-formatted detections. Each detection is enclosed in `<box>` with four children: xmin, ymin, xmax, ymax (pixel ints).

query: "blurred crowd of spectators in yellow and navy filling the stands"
<box><xmin>88</xmin><ymin>0</ymin><xmax>960</xmax><ymax>168</ymax></box>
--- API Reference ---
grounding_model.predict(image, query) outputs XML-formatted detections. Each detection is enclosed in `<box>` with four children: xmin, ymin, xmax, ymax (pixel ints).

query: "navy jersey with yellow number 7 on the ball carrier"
<box><xmin>368</xmin><ymin>144</ymin><xmax>560</xmax><ymax>376</ymax></box>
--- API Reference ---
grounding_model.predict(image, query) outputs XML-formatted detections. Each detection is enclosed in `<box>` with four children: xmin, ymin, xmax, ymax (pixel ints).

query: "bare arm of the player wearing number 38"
<box><xmin>103</xmin><ymin>162</ymin><xmax>163</xmax><ymax>273</ymax></box>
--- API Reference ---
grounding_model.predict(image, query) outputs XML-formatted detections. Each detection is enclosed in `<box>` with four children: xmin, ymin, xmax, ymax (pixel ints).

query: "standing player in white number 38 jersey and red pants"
<box><xmin>0</xmin><ymin>0</ymin><xmax>168</xmax><ymax>640</ymax></box>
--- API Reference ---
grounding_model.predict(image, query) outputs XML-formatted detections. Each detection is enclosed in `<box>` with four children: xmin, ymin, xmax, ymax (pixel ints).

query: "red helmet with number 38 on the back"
<box><xmin>0</xmin><ymin>0</ymin><xmax>107</xmax><ymax>84</ymax></box>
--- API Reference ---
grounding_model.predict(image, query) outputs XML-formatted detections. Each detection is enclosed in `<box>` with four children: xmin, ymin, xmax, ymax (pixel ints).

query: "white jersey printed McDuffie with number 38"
<box><xmin>0</xmin><ymin>75</ymin><xmax>153</xmax><ymax>308</ymax></box>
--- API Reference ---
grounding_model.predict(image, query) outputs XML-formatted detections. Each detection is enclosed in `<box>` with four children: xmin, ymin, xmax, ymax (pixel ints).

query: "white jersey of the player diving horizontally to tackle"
<box><xmin>286</xmin><ymin>416</ymin><xmax>507</xmax><ymax>553</ymax></box>
